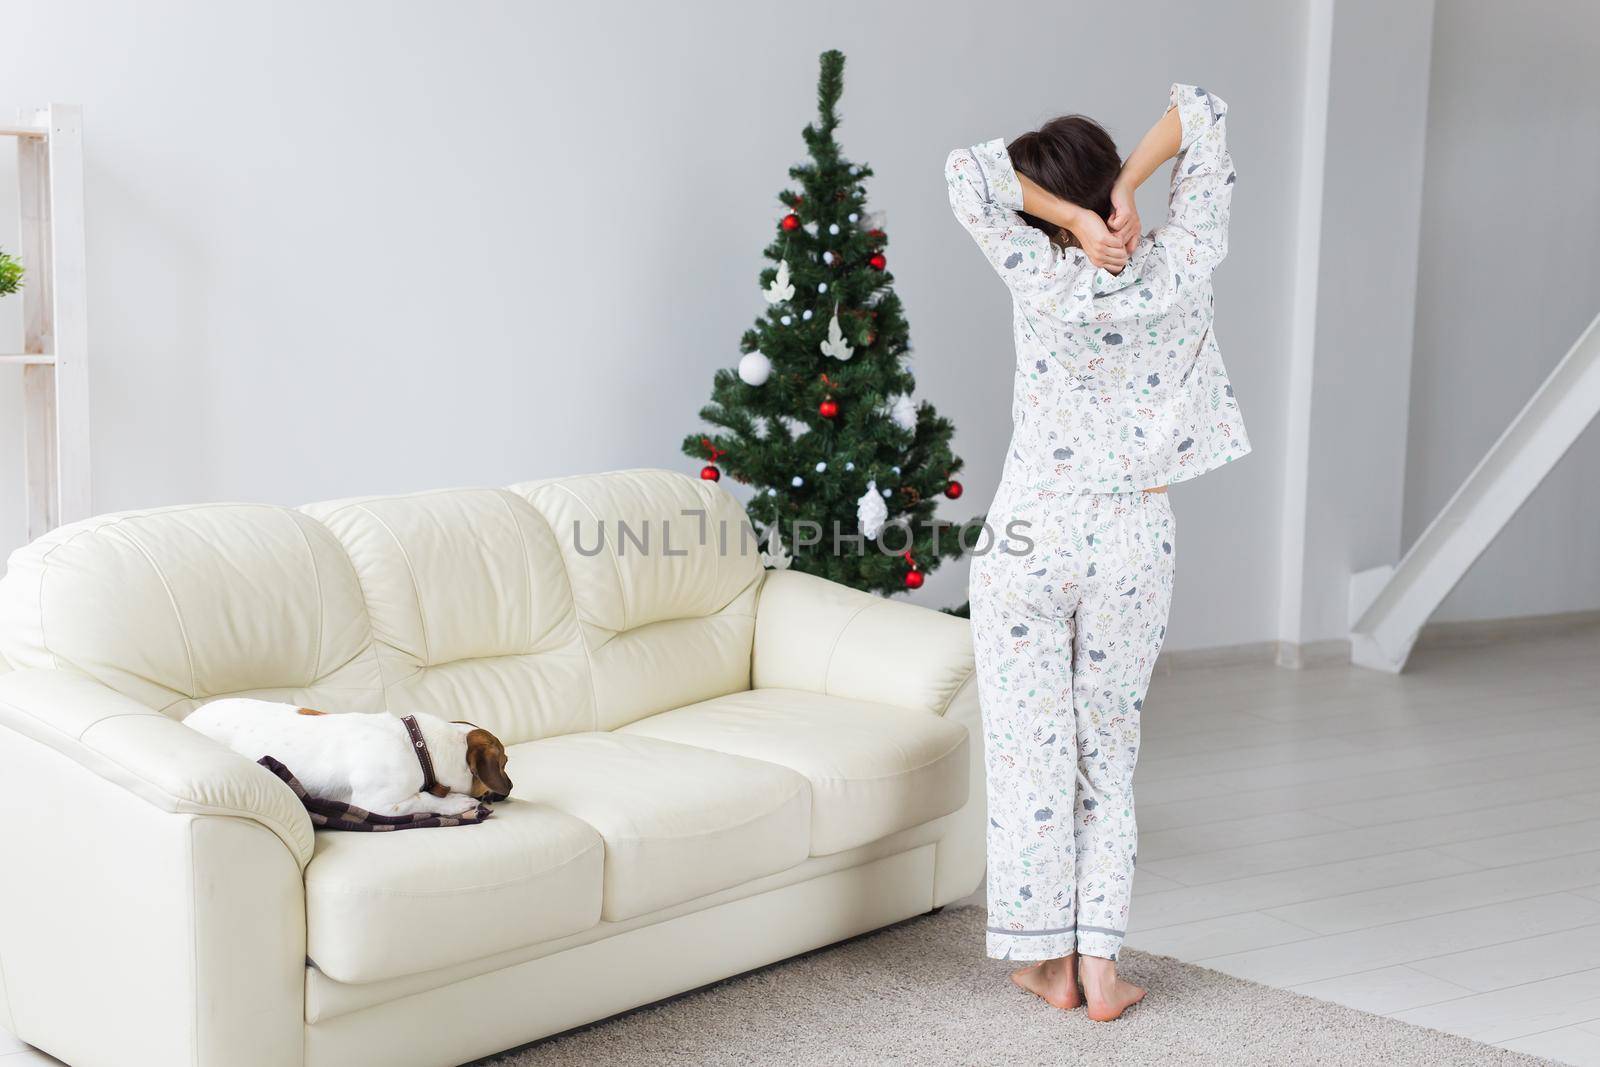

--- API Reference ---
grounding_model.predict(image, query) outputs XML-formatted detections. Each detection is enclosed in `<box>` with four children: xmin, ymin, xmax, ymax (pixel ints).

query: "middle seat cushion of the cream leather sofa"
<box><xmin>506</xmin><ymin>733</ymin><xmax>811</xmax><ymax>921</ymax></box>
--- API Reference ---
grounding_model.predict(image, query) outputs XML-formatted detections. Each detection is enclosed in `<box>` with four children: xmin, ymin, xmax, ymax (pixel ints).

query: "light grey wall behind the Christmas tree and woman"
<box><xmin>0</xmin><ymin>0</ymin><xmax>1304</xmax><ymax>648</ymax></box>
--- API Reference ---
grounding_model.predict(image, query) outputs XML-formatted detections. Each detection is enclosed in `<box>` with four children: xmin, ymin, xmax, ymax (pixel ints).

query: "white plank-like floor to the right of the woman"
<box><xmin>1128</xmin><ymin>627</ymin><xmax>1600</xmax><ymax>1067</ymax></box>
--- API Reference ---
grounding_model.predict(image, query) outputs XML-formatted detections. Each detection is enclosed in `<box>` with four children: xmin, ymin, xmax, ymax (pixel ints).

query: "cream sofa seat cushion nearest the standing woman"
<box><xmin>621</xmin><ymin>689</ymin><xmax>968</xmax><ymax>856</ymax></box>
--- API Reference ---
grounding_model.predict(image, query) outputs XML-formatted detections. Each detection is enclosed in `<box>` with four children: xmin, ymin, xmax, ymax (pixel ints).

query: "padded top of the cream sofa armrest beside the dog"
<box><xmin>0</xmin><ymin>669</ymin><xmax>315</xmax><ymax>870</ymax></box>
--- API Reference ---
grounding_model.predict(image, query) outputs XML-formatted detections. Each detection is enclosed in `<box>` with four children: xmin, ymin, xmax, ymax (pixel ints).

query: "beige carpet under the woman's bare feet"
<box><xmin>483</xmin><ymin>907</ymin><xmax>1550</xmax><ymax>1067</ymax></box>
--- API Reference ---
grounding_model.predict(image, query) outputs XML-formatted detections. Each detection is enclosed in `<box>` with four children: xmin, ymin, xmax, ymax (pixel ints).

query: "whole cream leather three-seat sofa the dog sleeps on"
<box><xmin>0</xmin><ymin>470</ymin><xmax>984</xmax><ymax>1067</ymax></box>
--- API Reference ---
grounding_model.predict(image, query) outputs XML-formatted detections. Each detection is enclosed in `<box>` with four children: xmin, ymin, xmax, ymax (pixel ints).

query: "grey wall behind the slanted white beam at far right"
<box><xmin>1405</xmin><ymin>0</ymin><xmax>1600</xmax><ymax>619</ymax></box>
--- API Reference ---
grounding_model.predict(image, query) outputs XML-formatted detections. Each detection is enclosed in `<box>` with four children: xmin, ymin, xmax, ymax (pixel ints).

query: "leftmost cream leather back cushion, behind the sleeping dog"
<box><xmin>0</xmin><ymin>504</ymin><xmax>382</xmax><ymax>718</ymax></box>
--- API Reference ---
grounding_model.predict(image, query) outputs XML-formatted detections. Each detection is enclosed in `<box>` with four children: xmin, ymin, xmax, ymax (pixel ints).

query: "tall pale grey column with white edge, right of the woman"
<box><xmin>1280</xmin><ymin>0</ymin><xmax>1434</xmax><ymax>664</ymax></box>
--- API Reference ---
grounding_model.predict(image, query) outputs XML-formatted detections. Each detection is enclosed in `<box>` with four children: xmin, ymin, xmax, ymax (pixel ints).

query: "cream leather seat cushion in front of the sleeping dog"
<box><xmin>306</xmin><ymin>801</ymin><xmax>605</xmax><ymax>982</ymax></box>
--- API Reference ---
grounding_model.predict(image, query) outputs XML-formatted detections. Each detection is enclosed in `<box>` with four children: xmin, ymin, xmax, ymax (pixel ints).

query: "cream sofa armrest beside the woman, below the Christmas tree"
<box><xmin>750</xmin><ymin>571</ymin><xmax>973</xmax><ymax>715</ymax></box>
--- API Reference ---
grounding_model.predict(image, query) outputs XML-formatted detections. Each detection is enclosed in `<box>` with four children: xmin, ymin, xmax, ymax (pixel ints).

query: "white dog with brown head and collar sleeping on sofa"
<box><xmin>184</xmin><ymin>697</ymin><xmax>510</xmax><ymax>816</ymax></box>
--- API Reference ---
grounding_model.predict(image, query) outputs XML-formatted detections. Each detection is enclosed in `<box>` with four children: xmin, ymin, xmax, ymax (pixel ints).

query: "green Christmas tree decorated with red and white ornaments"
<box><xmin>683</xmin><ymin>51</ymin><xmax>973</xmax><ymax>593</ymax></box>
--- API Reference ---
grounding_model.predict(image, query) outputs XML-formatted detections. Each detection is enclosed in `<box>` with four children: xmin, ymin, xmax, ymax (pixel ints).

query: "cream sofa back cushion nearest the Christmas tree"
<box><xmin>510</xmin><ymin>470</ymin><xmax>762</xmax><ymax>729</ymax></box>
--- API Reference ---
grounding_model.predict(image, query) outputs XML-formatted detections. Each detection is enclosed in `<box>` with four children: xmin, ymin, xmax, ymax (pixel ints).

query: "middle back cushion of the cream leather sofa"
<box><xmin>304</xmin><ymin>490</ymin><xmax>595</xmax><ymax>744</ymax></box>
